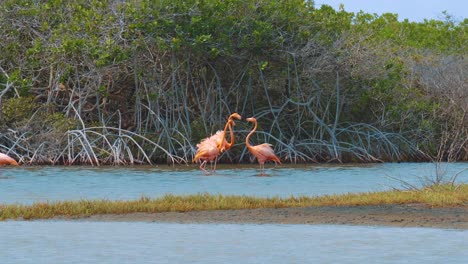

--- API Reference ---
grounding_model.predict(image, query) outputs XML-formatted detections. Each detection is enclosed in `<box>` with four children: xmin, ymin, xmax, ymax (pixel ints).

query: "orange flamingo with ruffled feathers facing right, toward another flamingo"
<box><xmin>193</xmin><ymin>113</ymin><xmax>241</xmax><ymax>173</ymax></box>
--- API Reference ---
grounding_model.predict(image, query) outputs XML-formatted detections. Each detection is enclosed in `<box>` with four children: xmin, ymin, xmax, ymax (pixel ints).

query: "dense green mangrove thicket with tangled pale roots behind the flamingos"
<box><xmin>0</xmin><ymin>0</ymin><xmax>468</xmax><ymax>163</ymax></box>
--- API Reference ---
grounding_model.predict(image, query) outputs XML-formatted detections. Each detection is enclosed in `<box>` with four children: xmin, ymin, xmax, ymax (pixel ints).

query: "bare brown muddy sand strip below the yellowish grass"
<box><xmin>70</xmin><ymin>204</ymin><xmax>468</xmax><ymax>229</ymax></box>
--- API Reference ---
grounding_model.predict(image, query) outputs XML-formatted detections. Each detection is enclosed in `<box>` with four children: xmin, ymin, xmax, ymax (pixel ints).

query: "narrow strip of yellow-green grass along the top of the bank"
<box><xmin>0</xmin><ymin>184</ymin><xmax>468</xmax><ymax>220</ymax></box>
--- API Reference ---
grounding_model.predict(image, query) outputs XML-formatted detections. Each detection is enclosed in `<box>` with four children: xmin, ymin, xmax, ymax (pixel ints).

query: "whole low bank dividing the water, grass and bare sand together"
<box><xmin>0</xmin><ymin>184</ymin><xmax>468</xmax><ymax>229</ymax></box>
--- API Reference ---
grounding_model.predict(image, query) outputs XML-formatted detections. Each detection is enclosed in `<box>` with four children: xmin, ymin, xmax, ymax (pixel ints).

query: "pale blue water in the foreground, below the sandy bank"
<box><xmin>0</xmin><ymin>221</ymin><xmax>468</xmax><ymax>264</ymax></box>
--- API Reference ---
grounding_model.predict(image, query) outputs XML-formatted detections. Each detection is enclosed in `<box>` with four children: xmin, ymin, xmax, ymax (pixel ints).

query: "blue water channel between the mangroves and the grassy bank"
<box><xmin>0</xmin><ymin>163</ymin><xmax>468</xmax><ymax>204</ymax></box>
